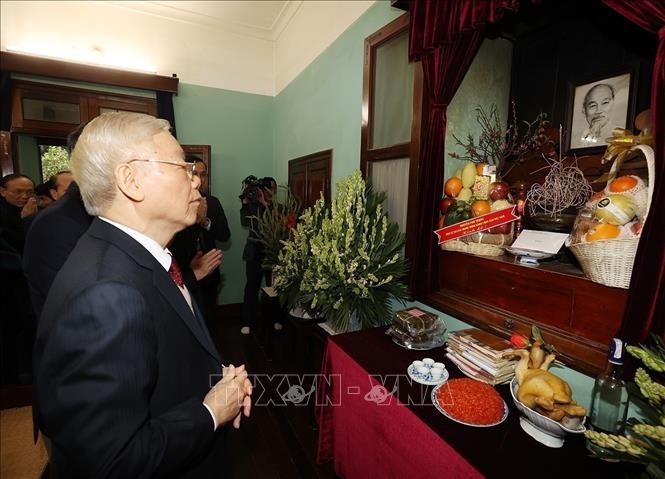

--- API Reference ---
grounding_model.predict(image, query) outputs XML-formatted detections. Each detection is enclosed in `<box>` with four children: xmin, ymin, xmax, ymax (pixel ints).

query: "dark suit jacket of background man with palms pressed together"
<box><xmin>170</xmin><ymin>195</ymin><xmax>231</xmax><ymax>290</ymax></box>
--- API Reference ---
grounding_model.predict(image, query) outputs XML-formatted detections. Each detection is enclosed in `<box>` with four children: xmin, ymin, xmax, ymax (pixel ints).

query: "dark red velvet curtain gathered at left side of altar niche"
<box><xmin>409</xmin><ymin>0</ymin><xmax>518</xmax><ymax>297</ymax></box>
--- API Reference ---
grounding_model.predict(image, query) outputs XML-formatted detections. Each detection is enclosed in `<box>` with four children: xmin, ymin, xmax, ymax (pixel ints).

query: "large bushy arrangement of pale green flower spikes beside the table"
<box><xmin>273</xmin><ymin>170</ymin><xmax>407</xmax><ymax>331</ymax></box>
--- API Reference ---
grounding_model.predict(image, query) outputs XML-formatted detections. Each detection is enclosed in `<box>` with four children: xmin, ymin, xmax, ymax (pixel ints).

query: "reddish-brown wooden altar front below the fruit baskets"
<box><xmin>429</xmin><ymin>251</ymin><xmax>627</xmax><ymax>374</ymax></box>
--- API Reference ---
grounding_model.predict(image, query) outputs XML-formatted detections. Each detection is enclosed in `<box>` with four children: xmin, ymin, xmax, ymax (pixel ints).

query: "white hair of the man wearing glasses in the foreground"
<box><xmin>70</xmin><ymin>112</ymin><xmax>170</xmax><ymax>216</ymax></box>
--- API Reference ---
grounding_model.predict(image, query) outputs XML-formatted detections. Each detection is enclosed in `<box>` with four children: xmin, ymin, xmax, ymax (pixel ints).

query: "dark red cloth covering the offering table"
<box><xmin>317</xmin><ymin>328</ymin><xmax>640</xmax><ymax>479</ymax></box>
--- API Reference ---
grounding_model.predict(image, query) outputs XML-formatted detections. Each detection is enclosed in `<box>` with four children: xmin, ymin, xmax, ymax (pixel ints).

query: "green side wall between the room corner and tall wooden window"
<box><xmin>273</xmin><ymin>2</ymin><xmax>404</xmax><ymax>194</ymax></box>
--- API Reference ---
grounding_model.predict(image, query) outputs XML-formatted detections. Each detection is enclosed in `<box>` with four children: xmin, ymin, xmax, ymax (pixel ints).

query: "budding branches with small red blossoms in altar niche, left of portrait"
<box><xmin>449</xmin><ymin>101</ymin><xmax>552</xmax><ymax>177</ymax></box>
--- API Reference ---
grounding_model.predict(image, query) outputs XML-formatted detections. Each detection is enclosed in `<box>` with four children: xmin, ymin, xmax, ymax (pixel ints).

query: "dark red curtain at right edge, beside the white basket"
<box><xmin>604</xmin><ymin>0</ymin><xmax>665</xmax><ymax>343</ymax></box>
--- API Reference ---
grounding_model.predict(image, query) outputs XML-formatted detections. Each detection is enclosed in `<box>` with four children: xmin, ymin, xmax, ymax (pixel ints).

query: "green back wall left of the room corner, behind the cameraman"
<box><xmin>173</xmin><ymin>83</ymin><xmax>274</xmax><ymax>304</ymax></box>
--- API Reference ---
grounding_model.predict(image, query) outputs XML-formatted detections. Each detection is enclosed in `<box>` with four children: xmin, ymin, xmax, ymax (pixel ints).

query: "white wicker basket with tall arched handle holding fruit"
<box><xmin>570</xmin><ymin>145</ymin><xmax>655</xmax><ymax>289</ymax></box>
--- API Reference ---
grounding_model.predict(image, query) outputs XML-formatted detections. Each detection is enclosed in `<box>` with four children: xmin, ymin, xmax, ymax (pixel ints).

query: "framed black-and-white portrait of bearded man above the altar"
<box><xmin>564</xmin><ymin>68</ymin><xmax>637</xmax><ymax>154</ymax></box>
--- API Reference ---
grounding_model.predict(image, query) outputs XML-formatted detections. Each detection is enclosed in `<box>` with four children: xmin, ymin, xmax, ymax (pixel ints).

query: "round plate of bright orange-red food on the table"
<box><xmin>432</xmin><ymin>378</ymin><xmax>508</xmax><ymax>427</ymax></box>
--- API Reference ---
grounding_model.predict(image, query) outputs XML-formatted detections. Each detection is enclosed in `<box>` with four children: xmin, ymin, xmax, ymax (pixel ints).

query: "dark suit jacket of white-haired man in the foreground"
<box><xmin>34</xmin><ymin>219</ymin><xmax>223</xmax><ymax>479</ymax></box>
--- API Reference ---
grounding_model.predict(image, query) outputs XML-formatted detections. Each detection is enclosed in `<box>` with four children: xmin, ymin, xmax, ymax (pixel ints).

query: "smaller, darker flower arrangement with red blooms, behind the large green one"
<box><xmin>252</xmin><ymin>186</ymin><xmax>300</xmax><ymax>270</ymax></box>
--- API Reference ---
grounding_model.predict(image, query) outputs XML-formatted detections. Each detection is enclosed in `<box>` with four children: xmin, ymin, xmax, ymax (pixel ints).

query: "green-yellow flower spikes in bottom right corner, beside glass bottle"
<box><xmin>585</xmin><ymin>334</ymin><xmax>665</xmax><ymax>478</ymax></box>
